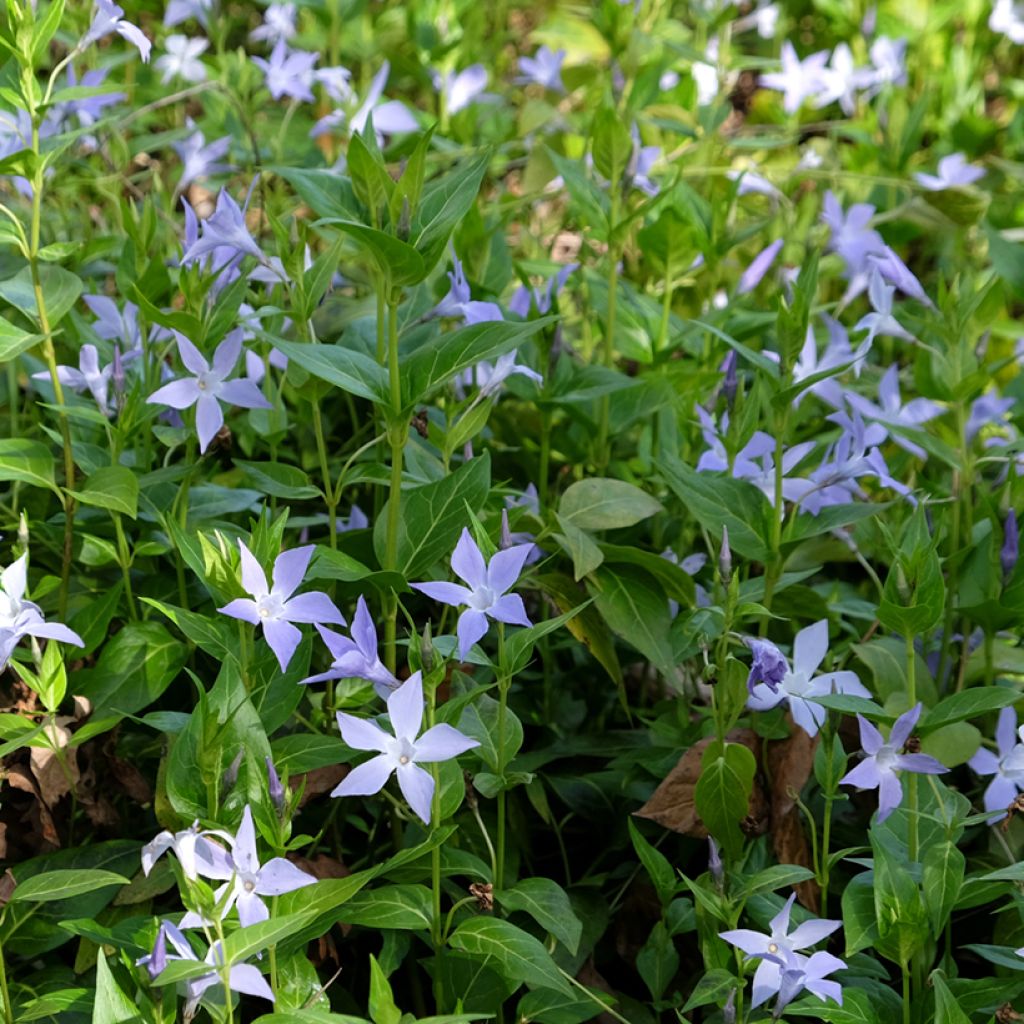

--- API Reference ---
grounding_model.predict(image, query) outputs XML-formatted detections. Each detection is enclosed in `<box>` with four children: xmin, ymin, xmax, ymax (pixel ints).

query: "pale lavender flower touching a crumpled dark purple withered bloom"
<box><xmin>746</xmin><ymin>618</ymin><xmax>871</xmax><ymax>736</ymax></box>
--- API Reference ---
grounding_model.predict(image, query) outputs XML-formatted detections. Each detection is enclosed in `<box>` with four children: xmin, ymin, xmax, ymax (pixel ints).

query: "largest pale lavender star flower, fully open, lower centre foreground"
<box><xmin>331</xmin><ymin>672</ymin><xmax>480</xmax><ymax>824</ymax></box>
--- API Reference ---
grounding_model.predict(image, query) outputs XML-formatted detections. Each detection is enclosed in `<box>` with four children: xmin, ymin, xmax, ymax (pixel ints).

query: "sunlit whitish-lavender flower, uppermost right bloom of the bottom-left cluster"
<box><xmin>181</xmin><ymin>804</ymin><xmax>316</xmax><ymax>928</ymax></box>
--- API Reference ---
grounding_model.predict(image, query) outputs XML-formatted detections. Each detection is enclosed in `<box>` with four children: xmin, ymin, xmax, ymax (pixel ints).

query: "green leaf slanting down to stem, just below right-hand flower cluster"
<box><xmin>658</xmin><ymin>453</ymin><xmax>773</xmax><ymax>562</ymax></box>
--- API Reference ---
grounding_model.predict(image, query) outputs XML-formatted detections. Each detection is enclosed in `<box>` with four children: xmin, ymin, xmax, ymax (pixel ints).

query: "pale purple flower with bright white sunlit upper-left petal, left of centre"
<box><xmin>217</xmin><ymin>540</ymin><xmax>345</xmax><ymax>672</ymax></box>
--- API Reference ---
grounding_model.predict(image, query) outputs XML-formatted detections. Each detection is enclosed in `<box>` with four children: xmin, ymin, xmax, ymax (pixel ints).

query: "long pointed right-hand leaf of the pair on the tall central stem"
<box><xmin>401</xmin><ymin>316</ymin><xmax>556</xmax><ymax>407</ymax></box>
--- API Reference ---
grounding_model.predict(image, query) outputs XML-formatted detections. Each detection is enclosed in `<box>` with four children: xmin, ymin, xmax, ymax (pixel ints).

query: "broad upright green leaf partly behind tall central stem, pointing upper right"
<box><xmin>374</xmin><ymin>452</ymin><xmax>490</xmax><ymax>580</ymax></box>
